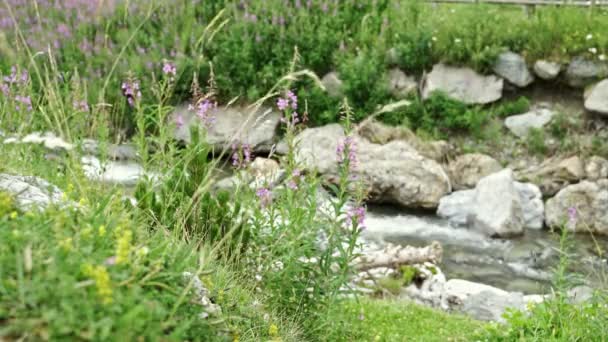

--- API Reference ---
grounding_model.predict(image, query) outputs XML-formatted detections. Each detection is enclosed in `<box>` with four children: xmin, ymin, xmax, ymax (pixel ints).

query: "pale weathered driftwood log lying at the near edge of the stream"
<box><xmin>354</xmin><ymin>241</ymin><xmax>443</xmax><ymax>271</ymax></box>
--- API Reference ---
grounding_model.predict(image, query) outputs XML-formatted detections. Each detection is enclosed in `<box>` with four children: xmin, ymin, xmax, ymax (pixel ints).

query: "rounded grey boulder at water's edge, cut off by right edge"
<box><xmin>546</xmin><ymin>179</ymin><xmax>608</xmax><ymax>235</ymax></box>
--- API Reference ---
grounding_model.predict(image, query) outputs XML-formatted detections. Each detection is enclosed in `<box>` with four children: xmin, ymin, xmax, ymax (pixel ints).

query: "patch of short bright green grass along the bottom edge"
<box><xmin>326</xmin><ymin>298</ymin><xmax>485</xmax><ymax>342</ymax></box>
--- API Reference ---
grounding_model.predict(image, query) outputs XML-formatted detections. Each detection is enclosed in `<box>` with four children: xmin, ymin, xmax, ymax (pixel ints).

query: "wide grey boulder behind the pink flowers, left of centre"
<box><xmin>172</xmin><ymin>107</ymin><xmax>281</xmax><ymax>152</ymax></box>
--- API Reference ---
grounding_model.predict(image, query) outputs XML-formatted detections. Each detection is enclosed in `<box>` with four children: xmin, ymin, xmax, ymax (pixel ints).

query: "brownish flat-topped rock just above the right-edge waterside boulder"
<box><xmin>517</xmin><ymin>156</ymin><xmax>585</xmax><ymax>196</ymax></box>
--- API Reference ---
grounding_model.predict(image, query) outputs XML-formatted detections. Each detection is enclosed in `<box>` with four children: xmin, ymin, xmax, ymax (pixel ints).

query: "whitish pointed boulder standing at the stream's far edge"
<box><xmin>437</xmin><ymin>169</ymin><xmax>544</xmax><ymax>236</ymax></box>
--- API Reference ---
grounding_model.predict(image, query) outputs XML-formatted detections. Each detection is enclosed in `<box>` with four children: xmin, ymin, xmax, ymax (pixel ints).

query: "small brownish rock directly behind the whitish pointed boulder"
<box><xmin>447</xmin><ymin>153</ymin><xmax>502</xmax><ymax>190</ymax></box>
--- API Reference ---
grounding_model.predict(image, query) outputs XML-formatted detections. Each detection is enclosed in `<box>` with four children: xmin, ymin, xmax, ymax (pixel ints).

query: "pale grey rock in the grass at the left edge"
<box><xmin>0</xmin><ymin>173</ymin><xmax>63</xmax><ymax>211</ymax></box>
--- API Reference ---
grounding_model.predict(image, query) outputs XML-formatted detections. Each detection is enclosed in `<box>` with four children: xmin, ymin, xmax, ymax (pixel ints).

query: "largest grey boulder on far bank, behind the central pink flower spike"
<box><xmin>296</xmin><ymin>124</ymin><xmax>451</xmax><ymax>208</ymax></box>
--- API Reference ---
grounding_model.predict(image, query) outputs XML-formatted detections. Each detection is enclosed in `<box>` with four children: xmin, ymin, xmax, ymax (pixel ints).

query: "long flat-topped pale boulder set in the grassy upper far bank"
<box><xmin>422</xmin><ymin>64</ymin><xmax>503</xmax><ymax>104</ymax></box>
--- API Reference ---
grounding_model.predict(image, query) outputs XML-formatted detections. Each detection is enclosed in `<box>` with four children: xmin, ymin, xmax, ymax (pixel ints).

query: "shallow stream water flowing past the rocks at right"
<box><xmin>364</xmin><ymin>206</ymin><xmax>608</xmax><ymax>294</ymax></box>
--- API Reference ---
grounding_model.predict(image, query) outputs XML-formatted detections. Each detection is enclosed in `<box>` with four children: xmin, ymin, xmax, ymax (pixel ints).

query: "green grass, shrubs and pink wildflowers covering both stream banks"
<box><xmin>0</xmin><ymin>0</ymin><xmax>608</xmax><ymax>341</ymax></box>
